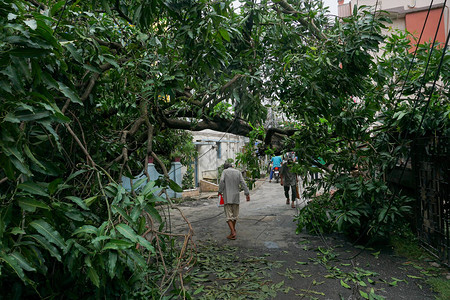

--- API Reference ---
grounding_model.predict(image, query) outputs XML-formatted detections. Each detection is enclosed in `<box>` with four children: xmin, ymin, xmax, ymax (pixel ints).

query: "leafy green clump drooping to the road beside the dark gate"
<box><xmin>288</xmin><ymin>12</ymin><xmax>449</xmax><ymax>242</ymax></box>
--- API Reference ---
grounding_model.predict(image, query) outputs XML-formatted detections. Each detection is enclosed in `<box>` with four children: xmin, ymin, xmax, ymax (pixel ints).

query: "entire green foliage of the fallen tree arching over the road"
<box><xmin>0</xmin><ymin>0</ymin><xmax>450</xmax><ymax>299</ymax></box>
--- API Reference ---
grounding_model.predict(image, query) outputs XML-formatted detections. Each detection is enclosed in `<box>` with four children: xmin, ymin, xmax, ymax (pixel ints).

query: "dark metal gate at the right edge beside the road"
<box><xmin>412</xmin><ymin>136</ymin><xmax>450</xmax><ymax>266</ymax></box>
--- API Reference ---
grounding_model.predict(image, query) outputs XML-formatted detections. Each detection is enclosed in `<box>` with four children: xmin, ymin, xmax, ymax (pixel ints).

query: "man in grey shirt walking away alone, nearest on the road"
<box><xmin>219</xmin><ymin>163</ymin><xmax>250</xmax><ymax>240</ymax></box>
